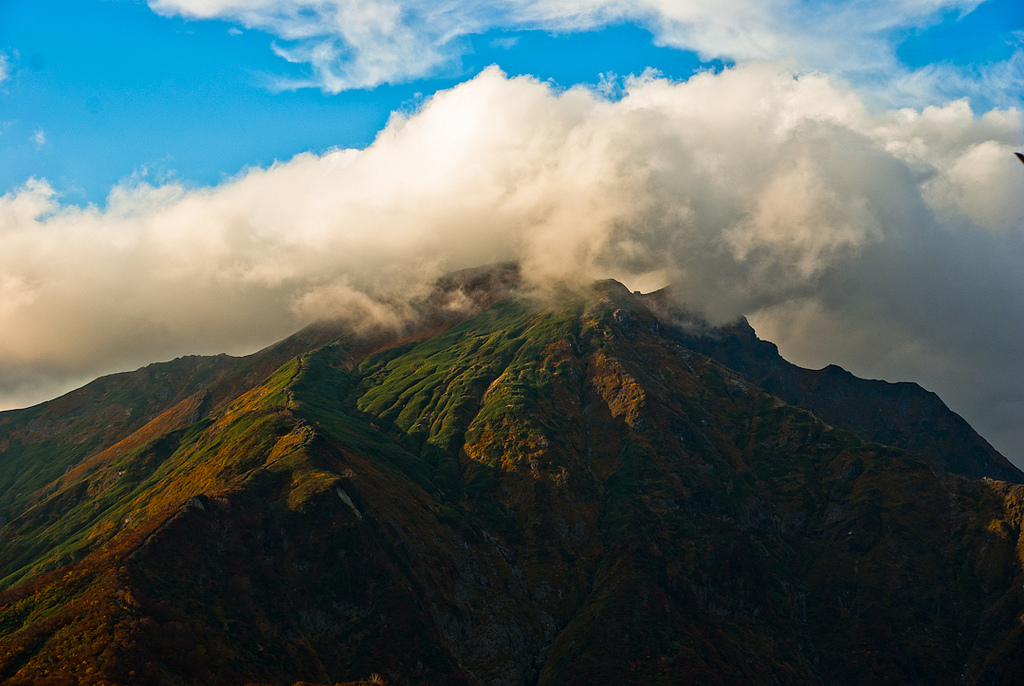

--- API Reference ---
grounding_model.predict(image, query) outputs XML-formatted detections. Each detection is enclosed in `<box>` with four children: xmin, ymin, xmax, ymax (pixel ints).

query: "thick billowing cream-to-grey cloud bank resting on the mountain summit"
<box><xmin>0</xmin><ymin>65</ymin><xmax>1024</xmax><ymax>459</ymax></box>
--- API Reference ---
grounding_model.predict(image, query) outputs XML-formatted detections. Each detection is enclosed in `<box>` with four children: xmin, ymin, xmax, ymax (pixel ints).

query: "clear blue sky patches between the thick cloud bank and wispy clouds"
<box><xmin>0</xmin><ymin>0</ymin><xmax>1024</xmax><ymax>204</ymax></box>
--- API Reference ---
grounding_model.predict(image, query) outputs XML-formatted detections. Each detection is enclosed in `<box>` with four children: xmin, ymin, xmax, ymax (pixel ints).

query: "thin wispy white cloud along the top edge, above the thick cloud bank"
<box><xmin>150</xmin><ymin>0</ymin><xmax>1024</xmax><ymax>104</ymax></box>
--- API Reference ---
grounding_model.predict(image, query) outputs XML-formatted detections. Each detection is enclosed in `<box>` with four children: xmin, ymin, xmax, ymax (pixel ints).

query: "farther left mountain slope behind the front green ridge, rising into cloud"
<box><xmin>0</xmin><ymin>263</ymin><xmax>519</xmax><ymax>588</ymax></box>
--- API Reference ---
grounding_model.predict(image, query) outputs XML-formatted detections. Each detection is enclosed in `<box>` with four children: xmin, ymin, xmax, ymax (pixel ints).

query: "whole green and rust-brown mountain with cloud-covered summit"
<box><xmin>0</xmin><ymin>265</ymin><xmax>1024</xmax><ymax>685</ymax></box>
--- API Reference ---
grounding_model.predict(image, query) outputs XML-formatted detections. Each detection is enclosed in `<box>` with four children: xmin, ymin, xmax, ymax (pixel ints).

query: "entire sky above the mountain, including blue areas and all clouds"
<box><xmin>0</xmin><ymin>0</ymin><xmax>1024</xmax><ymax>465</ymax></box>
